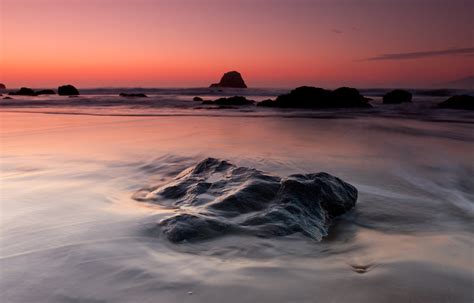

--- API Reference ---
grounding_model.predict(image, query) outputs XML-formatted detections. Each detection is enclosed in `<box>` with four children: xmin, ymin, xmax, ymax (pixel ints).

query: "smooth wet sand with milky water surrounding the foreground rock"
<box><xmin>0</xmin><ymin>112</ymin><xmax>474</xmax><ymax>303</ymax></box>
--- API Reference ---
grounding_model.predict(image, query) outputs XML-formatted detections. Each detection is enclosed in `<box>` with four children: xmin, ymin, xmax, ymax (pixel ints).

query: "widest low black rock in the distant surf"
<box><xmin>257</xmin><ymin>86</ymin><xmax>372</xmax><ymax>108</ymax></box>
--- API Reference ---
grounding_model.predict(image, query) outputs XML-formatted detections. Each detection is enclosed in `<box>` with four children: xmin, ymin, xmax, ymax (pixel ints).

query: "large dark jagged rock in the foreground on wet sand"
<box><xmin>134</xmin><ymin>158</ymin><xmax>357</xmax><ymax>242</ymax></box>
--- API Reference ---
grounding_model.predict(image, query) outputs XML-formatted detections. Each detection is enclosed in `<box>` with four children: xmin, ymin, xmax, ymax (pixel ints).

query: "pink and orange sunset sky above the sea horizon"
<box><xmin>0</xmin><ymin>0</ymin><xmax>474</xmax><ymax>88</ymax></box>
